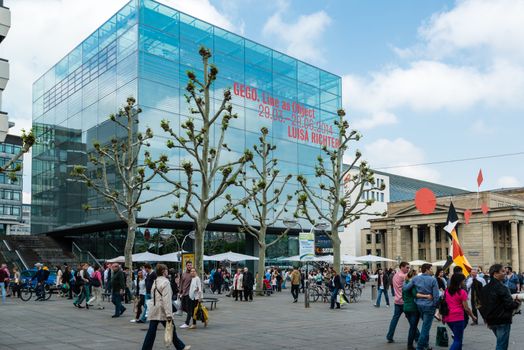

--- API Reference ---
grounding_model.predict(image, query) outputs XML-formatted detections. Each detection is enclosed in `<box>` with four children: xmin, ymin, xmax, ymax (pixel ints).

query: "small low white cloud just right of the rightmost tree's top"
<box><xmin>363</xmin><ymin>137</ymin><xmax>440</xmax><ymax>182</ymax></box>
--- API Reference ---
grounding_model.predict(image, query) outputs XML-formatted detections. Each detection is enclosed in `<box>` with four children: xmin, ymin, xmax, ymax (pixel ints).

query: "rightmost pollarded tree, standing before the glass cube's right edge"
<box><xmin>295</xmin><ymin>109</ymin><xmax>386</xmax><ymax>269</ymax></box>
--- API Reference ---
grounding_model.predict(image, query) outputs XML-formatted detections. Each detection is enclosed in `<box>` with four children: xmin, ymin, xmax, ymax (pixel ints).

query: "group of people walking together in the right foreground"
<box><xmin>382</xmin><ymin>262</ymin><xmax>523</xmax><ymax>350</ymax></box>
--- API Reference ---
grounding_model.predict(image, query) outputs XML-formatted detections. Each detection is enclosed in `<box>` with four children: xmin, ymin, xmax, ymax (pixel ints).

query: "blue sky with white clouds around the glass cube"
<box><xmin>0</xmin><ymin>0</ymin><xmax>524</xmax><ymax>201</ymax></box>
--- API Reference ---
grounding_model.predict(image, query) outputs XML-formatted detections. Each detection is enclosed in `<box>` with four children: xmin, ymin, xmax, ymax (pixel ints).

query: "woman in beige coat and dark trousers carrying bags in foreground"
<box><xmin>142</xmin><ymin>264</ymin><xmax>191</xmax><ymax>350</ymax></box>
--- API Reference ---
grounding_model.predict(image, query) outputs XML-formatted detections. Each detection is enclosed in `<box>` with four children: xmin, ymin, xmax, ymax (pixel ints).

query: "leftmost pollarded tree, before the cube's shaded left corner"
<box><xmin>71</xmin><ymin>97</ymin><xmax>177</xmax><ymax>278</ymax></box>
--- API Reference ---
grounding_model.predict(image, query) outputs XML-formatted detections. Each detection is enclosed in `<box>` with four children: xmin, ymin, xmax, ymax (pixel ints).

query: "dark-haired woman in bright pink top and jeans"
<box><xmin>444</xmin><ymin>273</ymin><xmax>477</xmax><ymax>350</ymax></box>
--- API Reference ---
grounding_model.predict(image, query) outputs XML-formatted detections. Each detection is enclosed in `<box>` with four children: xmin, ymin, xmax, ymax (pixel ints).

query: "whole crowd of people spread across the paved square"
<box><xmin>0</xmin><ymin>262</ymin><xmax>524</xmax><ymax>350</ymax></box>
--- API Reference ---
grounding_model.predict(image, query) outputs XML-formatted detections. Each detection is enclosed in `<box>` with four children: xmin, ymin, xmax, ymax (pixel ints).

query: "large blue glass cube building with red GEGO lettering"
<box><xmin>31</xmin><ymin>0</ymin><xmax>341</xmax><ymax>258</ymax></box>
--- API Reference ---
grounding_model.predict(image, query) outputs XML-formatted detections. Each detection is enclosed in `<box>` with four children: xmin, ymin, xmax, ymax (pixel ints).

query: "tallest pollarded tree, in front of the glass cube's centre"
<box><xmin>161</xmin><ymin>47</ymin><xmax>253</xmax><ymax>272</ymax></box>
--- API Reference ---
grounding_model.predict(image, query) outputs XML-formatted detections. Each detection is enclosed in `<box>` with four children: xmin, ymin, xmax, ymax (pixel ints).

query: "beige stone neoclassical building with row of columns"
<box><xmin>361</xmin><ymin>188</ymin><xmax>524</xmax><ymax>271</ymax></box>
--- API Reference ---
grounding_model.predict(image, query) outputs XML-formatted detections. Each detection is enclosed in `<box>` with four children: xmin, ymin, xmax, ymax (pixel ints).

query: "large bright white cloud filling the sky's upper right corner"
<box><xmin>343</xmin><ymin>0</ymin><xmax>524</xmax><ymax>130</ymax></box>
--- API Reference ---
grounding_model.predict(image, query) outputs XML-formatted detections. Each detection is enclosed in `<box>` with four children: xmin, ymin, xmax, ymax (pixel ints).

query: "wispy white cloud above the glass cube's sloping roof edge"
<box><xmin>263</xmin><ymin>2</ymin><xmax>331</xmax><ymax>62</ymax></box>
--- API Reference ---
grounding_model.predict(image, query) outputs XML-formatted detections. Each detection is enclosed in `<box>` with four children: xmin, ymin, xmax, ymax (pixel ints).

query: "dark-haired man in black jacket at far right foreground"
<box><xmin>479</xmin><ymin>264</ymin><xmax>520</xmax><ymax>350</ymax></box>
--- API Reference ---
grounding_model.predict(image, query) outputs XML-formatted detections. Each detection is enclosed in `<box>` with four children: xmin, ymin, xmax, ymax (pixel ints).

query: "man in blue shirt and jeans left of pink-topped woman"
<box><xmin>404</xmin><ymin>264</ymin><xmax>439</xmax><ymax>350</ymax></box>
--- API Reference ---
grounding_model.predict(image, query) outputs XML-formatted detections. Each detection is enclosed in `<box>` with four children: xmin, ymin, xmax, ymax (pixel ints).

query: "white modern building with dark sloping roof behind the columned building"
<box><xmin>340</xmin><ymin>170</ymin><xmax>467</xmax><ymax>256</ymax></box>
